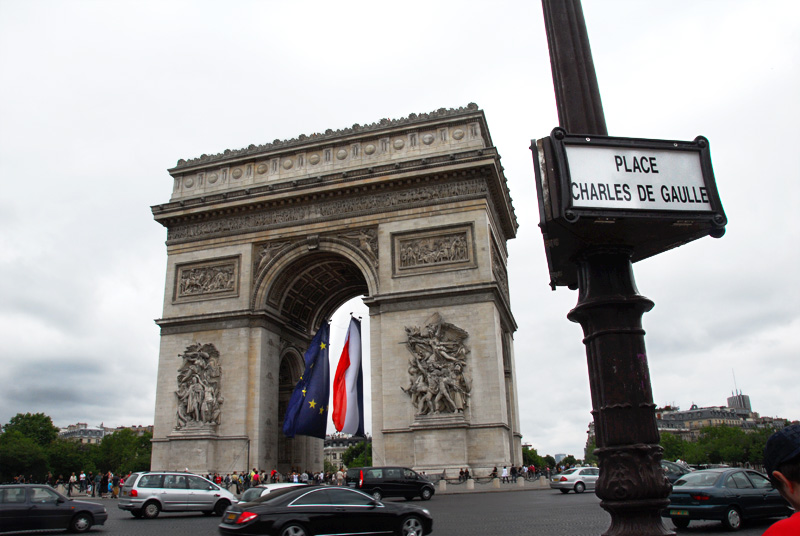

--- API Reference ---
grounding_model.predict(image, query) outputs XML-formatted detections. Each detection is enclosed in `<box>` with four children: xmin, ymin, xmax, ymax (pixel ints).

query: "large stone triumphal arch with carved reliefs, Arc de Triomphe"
<box><xmin>152</xmin><ymin>104</ymin><xmax>521</xmax><ymax>473</ymax></box>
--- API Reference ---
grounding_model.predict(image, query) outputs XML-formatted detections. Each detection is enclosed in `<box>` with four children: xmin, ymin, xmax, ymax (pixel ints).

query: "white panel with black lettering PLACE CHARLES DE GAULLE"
<box><xmin>565</xmin><ymin>145</ymin><xmax>711</xmax><ymax>212</ymax></box>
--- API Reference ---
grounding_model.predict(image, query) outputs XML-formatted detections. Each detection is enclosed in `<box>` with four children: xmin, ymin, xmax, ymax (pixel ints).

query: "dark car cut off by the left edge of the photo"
<box><xmin>0</xmin><ymin>484</ymin><xmax>108</xmax><ymax>532</ymax></box>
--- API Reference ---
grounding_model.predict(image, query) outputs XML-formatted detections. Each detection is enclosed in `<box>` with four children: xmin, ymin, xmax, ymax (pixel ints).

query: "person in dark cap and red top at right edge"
<box><xmin>764</xmin><ymin>424</ymin><xmax>800</xmax><ymax>536</ymax></box>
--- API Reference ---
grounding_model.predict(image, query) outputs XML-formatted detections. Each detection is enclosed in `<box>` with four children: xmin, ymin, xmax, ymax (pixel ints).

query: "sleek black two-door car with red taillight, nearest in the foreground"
<box><xmin>219</xmin><ymin>486</ymin><xmax>433</xmax><ymax>536</ymax></box>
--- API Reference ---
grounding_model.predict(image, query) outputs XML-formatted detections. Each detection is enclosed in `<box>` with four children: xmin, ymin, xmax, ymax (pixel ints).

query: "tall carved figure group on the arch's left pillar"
<box><xmin>175</xmin><ymin>343</ymin><xmax>224</xmax><ymax>430</ymax></box>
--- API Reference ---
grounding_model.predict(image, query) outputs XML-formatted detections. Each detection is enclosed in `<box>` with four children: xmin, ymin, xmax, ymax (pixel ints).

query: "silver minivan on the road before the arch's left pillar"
<box><xmin>117</xmin><ymin>471</ymin><xmax>238</xmax><ymax>519</ymax></box>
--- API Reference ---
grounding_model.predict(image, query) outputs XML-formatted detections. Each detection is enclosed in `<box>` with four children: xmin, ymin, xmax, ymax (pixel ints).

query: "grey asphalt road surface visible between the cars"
<box><xmin>3</xmin><ymin>490</ymin><xmax>774</xmax><ymax>536</ymax></box>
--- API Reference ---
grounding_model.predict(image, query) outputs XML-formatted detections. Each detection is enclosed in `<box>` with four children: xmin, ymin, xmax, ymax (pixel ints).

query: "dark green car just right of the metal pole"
<box><xmin>662</xmin><ymin>468</ymin><xmax>791</xmax><ymax>530</ymax></box>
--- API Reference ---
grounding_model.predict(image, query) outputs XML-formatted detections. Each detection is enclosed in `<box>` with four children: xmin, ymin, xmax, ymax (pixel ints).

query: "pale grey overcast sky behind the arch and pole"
<box><xmin>0</xmin><ymin>0</ymin><xmax>800</xmax><ymax>457</ymax></box>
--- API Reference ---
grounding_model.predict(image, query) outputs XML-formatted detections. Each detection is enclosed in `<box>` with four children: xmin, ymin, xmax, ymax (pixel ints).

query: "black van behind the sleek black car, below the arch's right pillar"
<box><xmin>345</xmin><ymin>467</ymin><xmax>436</xmax><ymax>501</ymax></box>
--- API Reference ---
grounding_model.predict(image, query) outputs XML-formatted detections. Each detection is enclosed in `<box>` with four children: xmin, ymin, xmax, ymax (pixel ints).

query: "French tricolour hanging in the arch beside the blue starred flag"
<box><xmin>333</xmin><ymin>317</ymin><xmax>364</xmax><ymax>436</ymax></box>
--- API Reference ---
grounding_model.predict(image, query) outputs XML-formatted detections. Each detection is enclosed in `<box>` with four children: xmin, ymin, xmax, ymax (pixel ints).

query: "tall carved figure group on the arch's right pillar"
<box><xmin>400</xmin><ymin>313</ymin><xmax>472</xmax><ymax>415</ymax></box>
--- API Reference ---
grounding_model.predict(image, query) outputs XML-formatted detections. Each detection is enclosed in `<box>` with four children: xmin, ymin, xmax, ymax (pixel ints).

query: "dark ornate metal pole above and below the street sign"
<box><xmin>542</xmin><ymin>0</ymin><xmax>675</xmax><ymax>536</ymax></box>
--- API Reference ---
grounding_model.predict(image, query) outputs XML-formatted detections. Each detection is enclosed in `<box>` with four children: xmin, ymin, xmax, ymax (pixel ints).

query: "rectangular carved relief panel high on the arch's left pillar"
<box><xmin>174</xmin><ymin>257</ymin><xmax>239</xmax><ymax>301</ymax></box>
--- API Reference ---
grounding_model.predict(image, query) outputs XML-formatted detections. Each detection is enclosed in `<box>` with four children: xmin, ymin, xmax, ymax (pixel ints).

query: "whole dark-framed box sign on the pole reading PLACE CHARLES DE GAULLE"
<box><xmin>531</xmin><ymin>128</ymin><xmax>727</xmax><ymax>288</ymax></box>
